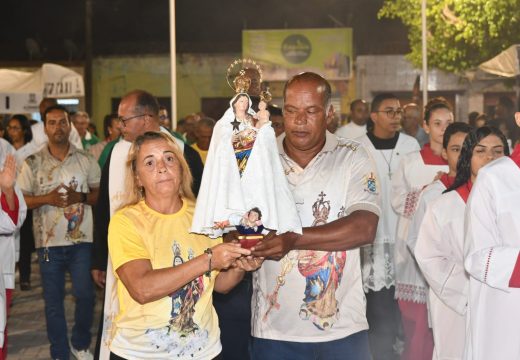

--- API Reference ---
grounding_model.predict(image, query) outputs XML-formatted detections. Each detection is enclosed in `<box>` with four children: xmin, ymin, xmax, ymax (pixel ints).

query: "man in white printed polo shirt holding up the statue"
<box><xmin>251</xmin><ymin>73</ymin><xmax>380</xmax><ymax>360</ymax></box>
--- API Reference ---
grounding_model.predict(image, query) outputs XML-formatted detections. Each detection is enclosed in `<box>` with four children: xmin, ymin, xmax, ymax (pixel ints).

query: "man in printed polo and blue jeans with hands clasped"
<box><xmin>18</xmin><ymin>105</ymin><xmax>100</xmax><ymax>359</ymax></box>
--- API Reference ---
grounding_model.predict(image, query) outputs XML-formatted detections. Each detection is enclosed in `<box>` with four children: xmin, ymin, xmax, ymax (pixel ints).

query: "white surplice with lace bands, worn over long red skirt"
<box><xmin>392</xmin><ymin>144</ymin><xmax>448</xmax><ymax>304</ymax></box>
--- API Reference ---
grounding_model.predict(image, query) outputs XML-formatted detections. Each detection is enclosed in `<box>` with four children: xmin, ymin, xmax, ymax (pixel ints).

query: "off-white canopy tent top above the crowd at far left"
<box><xmin>0</xmin><ymin>64</ymin><xmax>85</xmax><ymax>113</ymax></box>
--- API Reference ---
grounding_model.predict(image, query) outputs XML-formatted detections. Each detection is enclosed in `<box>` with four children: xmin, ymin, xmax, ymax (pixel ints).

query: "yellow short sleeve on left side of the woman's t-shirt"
<box><xmin>108</xmin><ymin>210</ymin><xmax>151</xmax><ymax>277</ymax></box>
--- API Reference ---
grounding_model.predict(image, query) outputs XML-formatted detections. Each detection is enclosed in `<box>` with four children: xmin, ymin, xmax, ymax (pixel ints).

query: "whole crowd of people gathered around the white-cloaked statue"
<box><xmin>0</xmin><ymin>73</ymin><xmax>520</xmax><ymax>360</ymax></box>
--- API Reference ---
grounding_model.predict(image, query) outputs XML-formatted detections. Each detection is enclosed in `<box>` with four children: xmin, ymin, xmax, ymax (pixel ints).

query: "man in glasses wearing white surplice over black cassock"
<box><xmin>356</xmin><ymin>93</ymin><xmax>420</xmax><ymax>360</ymax></box>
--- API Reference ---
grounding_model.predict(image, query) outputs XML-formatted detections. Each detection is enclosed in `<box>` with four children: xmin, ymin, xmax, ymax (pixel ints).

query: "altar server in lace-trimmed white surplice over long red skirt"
<box><xmin>392</xmin><ymin>98</ymin><xmax>453</xmax><ymax>360</ymax></box>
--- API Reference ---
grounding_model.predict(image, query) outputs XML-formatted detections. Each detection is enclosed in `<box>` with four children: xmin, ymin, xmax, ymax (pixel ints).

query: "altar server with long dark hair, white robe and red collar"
<box><xmin>415</xmin><ymin>126</ymin><xmax>509</xmax><ymax>360</ymax></box>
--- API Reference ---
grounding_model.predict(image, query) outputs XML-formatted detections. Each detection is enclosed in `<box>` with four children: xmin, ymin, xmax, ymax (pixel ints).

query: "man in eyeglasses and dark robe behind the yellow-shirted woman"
<box><xmin>92</xmin><ymin>90</ymin><xmax>203</xmax><ymax>359</ymax></box>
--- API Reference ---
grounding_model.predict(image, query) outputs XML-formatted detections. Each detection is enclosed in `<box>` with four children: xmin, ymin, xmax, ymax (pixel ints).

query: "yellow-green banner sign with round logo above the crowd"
<box><xmin>242</xmin><ymin>28</ymin><xmax>353</xmax><ymax>81</ymax></box>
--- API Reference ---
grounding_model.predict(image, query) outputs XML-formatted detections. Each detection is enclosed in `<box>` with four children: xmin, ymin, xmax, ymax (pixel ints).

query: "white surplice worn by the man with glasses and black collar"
<box><xmin>356</xmin><ymin>134</ymin><xmax>420</xmax><ymax>292</ymax></box>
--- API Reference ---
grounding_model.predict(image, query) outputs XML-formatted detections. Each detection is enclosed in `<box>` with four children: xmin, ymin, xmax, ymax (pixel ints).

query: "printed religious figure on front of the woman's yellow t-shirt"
<box><xmin>145</xmin><ymin>241</ymin><xmax>208</xmax><ymax>357</ymax></box>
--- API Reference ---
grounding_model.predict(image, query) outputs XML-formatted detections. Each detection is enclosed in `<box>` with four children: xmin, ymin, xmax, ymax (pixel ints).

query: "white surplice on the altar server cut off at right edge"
<box><xmin>464</xmin><ymin>157</ymin><xmax>520</xmax><ymax>360</ymax></box>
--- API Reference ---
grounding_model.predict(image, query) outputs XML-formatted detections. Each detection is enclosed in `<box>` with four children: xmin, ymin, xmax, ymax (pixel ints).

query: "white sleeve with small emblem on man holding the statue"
<box><xmin>345</xmin><ymin>144</ymin><xmax>381</xmax><ymax>216</ymax></box>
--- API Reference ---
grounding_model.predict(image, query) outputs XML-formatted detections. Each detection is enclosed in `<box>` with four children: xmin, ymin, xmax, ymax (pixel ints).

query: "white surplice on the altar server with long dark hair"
<box><xmin>415</xmin><ymin>190</ymin><xmax>469</xmax><ymax>360</ymax></box>
